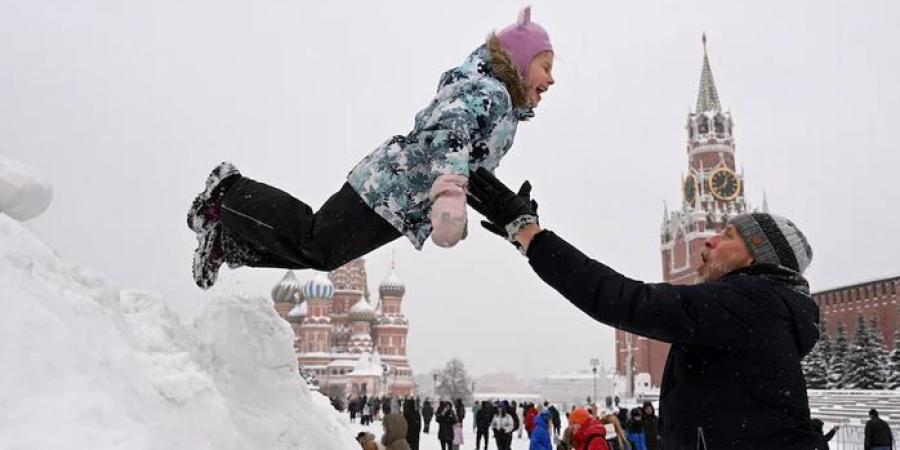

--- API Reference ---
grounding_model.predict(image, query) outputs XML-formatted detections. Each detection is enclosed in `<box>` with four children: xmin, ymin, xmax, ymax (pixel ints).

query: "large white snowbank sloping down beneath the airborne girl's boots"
<box><xmin>0</xmin><ymin>214</ymin><xmax>359</xmax><ymax>450</ymax></box>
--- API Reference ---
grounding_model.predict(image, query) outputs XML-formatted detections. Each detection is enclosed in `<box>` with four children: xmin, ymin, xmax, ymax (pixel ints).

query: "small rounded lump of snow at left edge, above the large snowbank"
<box><xmin>0</xmin><ymin>156</ymin><xmax>53</xmax><ymax>220</ymax></box>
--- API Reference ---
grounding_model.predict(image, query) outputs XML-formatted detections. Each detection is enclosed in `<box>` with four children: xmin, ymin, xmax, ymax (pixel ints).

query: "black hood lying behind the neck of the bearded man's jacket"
<box><xmin>723</xmin><ymin>264</ymin><xmax>819</xmax><ymax>356</ymax></box>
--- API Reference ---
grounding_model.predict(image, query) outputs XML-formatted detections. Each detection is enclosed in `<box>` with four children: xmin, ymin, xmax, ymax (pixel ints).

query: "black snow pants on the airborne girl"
<box><xmin>222</xmin><ymin>177</ymin><xmax>401</xmax><ymax>272</ymax></box>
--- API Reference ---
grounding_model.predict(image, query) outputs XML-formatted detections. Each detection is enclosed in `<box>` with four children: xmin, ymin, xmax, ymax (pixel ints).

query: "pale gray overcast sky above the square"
<box><xmin>0</xmin><ymin>0</ymin><xmax>900</xmax><ymax>375</ymax></box>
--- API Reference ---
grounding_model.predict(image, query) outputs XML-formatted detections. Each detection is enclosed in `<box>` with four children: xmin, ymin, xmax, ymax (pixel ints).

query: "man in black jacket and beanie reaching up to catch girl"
<box><xmin>469</xmin><ymin>169</ymin><xmax>819</xmax><ymax>450</ymax></box>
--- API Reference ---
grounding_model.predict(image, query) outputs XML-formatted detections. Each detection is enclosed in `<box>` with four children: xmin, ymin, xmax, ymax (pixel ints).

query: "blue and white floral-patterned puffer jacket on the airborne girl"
<box><xmin>347</xmin><ymin>36</ymin><xmax>534</xmax><ymax>250</ymax></box>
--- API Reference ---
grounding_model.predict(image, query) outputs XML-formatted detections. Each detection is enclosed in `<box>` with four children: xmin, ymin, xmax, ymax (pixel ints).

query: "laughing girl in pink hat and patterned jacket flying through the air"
<box><xmin>187</xmin><ymin>7</ymin><xmax>554</xmax><ymax>289</ymax></box>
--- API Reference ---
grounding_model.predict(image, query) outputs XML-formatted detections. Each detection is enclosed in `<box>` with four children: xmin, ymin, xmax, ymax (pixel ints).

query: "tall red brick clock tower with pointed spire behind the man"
<box><xmin>616</xmin><ymin>35</ymin><xmax>752</xmax><ymax>386</ymax></box>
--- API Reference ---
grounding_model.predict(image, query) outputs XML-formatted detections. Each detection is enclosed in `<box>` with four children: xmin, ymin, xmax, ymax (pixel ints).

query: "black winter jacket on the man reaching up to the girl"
<box><xmin>527</xmin><ymin>230</ymin><xmax>819</xmax><ymax>450</ymax></box>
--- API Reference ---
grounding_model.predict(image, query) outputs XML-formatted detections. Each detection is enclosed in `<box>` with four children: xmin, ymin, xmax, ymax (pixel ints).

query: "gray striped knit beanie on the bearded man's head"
<box><xmin>728</xmin><ymin>213</ymin><xmax>812</xmax><ymax>274</ymax></box>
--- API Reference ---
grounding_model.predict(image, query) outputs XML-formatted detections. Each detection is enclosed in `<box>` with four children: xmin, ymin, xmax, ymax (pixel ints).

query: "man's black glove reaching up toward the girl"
<box><xmin>468</xmin><ymin>167</ymin><xmax>538</xmax><ymax>247</ymax></box>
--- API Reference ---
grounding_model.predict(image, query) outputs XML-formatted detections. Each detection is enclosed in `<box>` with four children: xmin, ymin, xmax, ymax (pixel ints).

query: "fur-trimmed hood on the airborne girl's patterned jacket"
<box><xmin>438</xmin><ymin>34</ymin><xmax>534</xmax><ymax>120</ymax></box>
